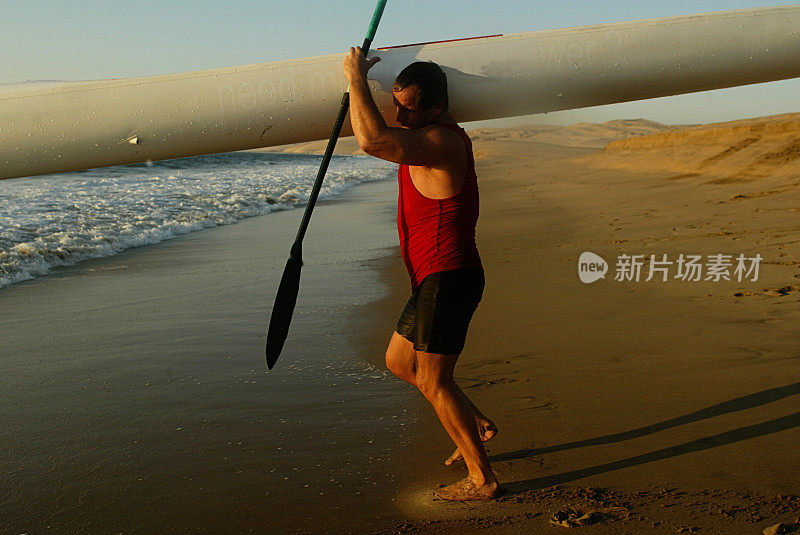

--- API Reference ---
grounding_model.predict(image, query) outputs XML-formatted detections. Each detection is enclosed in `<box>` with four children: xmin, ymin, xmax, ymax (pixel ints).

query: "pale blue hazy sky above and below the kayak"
<box><xmin>0</xmin><ymin>0</ymin><xmax>800</xmax><ymax>126</ymax></box>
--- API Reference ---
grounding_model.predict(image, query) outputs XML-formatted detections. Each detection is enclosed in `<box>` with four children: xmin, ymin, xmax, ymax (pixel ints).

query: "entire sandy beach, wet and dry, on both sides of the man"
<box><xmin>0</xmin><ymin>115</ymin><xmax>800</xmax><ymax>534</ymax></box>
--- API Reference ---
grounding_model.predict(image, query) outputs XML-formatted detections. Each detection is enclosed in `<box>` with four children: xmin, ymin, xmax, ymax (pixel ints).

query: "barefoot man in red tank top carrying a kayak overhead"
<box><xmin>343</xmin><ymin>47</ymin><xmax>500</xmax><ymax>501</ymax></box>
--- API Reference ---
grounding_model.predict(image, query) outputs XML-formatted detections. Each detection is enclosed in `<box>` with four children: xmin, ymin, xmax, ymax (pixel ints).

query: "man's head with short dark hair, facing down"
<box><xmin>392</xmin><ymin>61</ymin><xmax>448</xmax><ymax>128</ymax></box>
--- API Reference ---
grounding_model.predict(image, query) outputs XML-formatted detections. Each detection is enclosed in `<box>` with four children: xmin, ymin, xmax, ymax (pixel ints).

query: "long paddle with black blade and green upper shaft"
<box><xmin>266</xmin><ymin>0</ymin><xmax>386</xmax><ymax>370</ymax></box>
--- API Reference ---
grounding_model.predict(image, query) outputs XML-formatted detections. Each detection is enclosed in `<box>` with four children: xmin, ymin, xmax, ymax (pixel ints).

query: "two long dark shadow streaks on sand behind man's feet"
<box><xmin>490</xmin><ymin>383</ymin><xmax>800</xmax><ymax>495</ymax></box>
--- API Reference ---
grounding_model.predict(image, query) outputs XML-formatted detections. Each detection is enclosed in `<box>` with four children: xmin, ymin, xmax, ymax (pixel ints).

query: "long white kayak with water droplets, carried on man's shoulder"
<box><xmin>0</xmin><ymin>5</ymin><xmax>800</xmax><ymax>179</ymax></box>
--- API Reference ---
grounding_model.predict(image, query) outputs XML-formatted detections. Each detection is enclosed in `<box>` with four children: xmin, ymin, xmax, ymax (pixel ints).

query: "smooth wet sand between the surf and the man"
<box><xmin>0</xmin><ymin>181</ymin><xmax>418</xmax><ymax>533</ymax></box>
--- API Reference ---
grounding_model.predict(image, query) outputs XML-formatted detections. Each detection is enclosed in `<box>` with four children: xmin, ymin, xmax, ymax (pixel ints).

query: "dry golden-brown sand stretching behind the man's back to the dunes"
<box><xmin>374</xmin><ymin>115</ymin><xmax>800</xmax><ymax>534</ymax></box>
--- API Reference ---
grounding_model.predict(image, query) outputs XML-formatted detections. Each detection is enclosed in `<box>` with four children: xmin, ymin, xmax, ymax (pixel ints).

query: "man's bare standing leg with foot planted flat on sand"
<box><xmin>415</xmin><ymin>351</ymin><xmax>500</xmax><ymax>500</ymax></box>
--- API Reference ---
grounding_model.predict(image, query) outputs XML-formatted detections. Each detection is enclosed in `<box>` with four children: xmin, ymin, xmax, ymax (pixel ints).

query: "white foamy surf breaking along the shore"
<box><xmin>0</xmin><ymin>152</ymin><xmax>394</xmax><ymax>287</ymax></box>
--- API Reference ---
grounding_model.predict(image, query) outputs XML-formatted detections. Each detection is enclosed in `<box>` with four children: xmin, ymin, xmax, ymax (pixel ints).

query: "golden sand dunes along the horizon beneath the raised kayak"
<box><xmin>260</xmin><ymin>113</ymin><xmax>800</xmax><ymax>198</ymax></box>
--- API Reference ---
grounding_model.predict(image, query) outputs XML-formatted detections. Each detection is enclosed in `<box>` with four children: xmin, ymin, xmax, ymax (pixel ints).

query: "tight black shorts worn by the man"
<box><xmin>396</xmin><ymin>268</ymin><xmax>484</xmax><ymax>355</ymax></box>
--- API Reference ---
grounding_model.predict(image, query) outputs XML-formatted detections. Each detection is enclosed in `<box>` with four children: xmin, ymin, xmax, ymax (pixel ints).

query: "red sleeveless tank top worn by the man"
<box><xmin>397</xmin><ymin>124</ymin><xmax>482</xmax><ymax>288</ymax></box>
